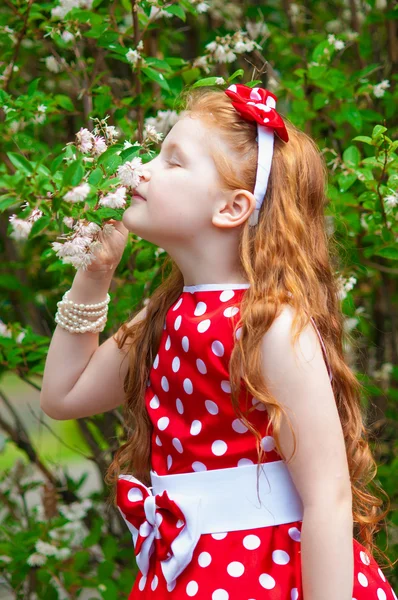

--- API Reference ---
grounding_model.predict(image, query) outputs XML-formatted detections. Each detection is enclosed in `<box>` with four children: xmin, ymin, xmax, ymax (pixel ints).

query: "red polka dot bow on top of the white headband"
<box><xmin>224</xmin><ymin>83</ymin><xmax>289</xmax><ymax>142</ymax></box>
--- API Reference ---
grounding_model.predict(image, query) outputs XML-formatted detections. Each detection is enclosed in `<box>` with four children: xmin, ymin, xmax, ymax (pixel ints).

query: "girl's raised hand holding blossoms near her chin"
<box><xmin>86</xmin><ymin>219</ymin><xmax>129</xmax><ymax>273</ymax></box>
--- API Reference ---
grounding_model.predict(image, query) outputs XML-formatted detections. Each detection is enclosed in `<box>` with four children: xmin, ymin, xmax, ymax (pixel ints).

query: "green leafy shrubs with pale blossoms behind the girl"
<box><xmin>0</xmin><ymin>0</ymin><xmax>398</xmax><ymax>600</ymax></box>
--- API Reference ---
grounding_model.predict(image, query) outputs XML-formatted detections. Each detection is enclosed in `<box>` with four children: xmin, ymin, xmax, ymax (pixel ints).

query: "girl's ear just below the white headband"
<box><xmin>212</xmin><ymin>189</ymin><xmax>256</xmax><ymax>228</ymax></box>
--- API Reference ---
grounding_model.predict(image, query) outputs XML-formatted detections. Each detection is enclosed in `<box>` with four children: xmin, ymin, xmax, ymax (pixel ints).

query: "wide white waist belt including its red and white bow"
<box><xmin>117</xmin><ymin>460</ymin><xmax>303</xmax><ymax>586</ymax></box>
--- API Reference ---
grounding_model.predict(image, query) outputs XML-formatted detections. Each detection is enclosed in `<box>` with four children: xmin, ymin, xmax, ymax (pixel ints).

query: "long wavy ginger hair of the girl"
<box><xmin>105</xmin><ymin>87</ymin><xmax>395</xmax><ymax>567</ymax></box>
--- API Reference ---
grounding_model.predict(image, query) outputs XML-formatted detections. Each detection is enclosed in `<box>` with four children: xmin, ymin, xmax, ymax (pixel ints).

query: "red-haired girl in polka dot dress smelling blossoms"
<box><xmin>41</xmin><ymin>84</ymin><xmax>397</xmax><ymax>600</ymax></box>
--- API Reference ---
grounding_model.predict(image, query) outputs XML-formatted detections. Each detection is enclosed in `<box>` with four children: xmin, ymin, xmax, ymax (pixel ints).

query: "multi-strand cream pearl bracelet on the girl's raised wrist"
<box><xmin>55</xmin><ymin>290</ymin><xmax>111</xmax><ymax>333</ymax></box>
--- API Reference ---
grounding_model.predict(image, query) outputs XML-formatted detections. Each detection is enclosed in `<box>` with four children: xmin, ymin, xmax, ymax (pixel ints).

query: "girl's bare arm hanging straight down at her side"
<box><xmin>261</xmin><ymin>305</ymin><xmax>354</xmax><ymax>600</ymax></box>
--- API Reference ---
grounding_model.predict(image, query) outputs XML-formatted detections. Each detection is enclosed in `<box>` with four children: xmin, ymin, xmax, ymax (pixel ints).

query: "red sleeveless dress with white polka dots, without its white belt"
<box><xmin>118</xmin><ymin>284</ymin><xmax>397</xmax><ymax>600</ymax></box>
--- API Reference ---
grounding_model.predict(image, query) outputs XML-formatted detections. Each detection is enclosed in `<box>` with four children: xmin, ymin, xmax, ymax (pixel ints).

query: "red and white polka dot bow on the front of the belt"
<box><xmin>116</xmin><ymin>475</ymin><xmax>201</xmax><ymax>585</ymax></box>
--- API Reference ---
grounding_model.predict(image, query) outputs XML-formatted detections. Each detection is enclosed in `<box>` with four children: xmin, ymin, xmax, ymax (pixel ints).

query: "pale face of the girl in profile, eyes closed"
<box><xmin>122</xmin><ymin>115</ymin><xmax>232</xmax><ymax>252</ymax></box>
